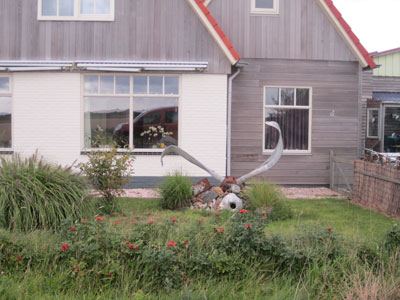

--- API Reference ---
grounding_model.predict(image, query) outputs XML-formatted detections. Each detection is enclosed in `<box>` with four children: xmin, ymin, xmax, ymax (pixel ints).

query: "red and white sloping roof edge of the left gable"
<box><xmin>186</xmin><ymin>0</ymin><xmax>240</xmax><ymax>65</ymax></box>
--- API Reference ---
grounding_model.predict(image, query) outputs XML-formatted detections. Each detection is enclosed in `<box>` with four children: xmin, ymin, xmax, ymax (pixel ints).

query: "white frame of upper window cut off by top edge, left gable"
<box><xmin>38</xmin><ymin>0</ymin><xmax>115</xmax><ymax>22</ymax></box>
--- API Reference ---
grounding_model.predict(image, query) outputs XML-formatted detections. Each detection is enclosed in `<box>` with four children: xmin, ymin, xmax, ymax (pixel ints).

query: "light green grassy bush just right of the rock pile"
<box><xmin>243</xmin><ymin>181</ymin><xmax>293</xmax><ymax>220</ymax></box>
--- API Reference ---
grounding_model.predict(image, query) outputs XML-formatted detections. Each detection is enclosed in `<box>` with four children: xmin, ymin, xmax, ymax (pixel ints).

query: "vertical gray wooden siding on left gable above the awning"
<box><xmin>0</xmin><ymin>0</ymin><xmax>231</xmax><ymax>73</ymax></box>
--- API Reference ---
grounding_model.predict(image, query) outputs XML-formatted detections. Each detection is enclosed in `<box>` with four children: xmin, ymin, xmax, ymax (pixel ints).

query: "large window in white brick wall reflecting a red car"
<box><xmin>83</xmin><ymin>75</ymin><xmax>179</xmax><ymax>150</ymax></box>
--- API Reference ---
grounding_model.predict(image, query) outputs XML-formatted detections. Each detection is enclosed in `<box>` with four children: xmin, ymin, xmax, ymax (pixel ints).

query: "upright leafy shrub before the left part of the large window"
<box><xmin>81</xmin><ymin>144</ymin><xmax>133</xmax><ymax>214</ymax></box>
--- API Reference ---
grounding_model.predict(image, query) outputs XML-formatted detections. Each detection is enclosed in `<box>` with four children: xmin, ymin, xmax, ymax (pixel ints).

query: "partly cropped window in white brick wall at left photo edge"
<box><xmin>0</xmin><ymin>75</ymin><xmax>12</xmax><ymax>150</ymax></box>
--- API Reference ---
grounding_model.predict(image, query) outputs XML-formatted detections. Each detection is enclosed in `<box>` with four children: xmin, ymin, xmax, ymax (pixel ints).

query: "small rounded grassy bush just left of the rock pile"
<box><xmin>161</xmin><ymin>172</ymin><xmax>192</xmax><ymax>209</ymax></box>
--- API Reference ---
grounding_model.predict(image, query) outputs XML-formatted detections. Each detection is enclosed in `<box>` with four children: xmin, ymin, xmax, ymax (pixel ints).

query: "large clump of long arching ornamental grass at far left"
<box><xmin>0</xmin><ymin>154</ymin><xmax>93</xmax><ymax>231</ymax></box>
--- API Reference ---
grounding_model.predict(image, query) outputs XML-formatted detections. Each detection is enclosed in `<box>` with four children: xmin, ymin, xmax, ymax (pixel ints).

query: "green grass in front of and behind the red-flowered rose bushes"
<box><xmin>0</xmin><ymin>198</ymin><xmax>400</xmax><ymax>300</ymax></box>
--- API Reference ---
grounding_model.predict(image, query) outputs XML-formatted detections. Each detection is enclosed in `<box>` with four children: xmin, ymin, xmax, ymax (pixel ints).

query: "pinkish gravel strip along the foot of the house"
<box><xmin>123</xmin><ymin>187</ymin><xmax>345</xmax><ymax>199</ymax></box>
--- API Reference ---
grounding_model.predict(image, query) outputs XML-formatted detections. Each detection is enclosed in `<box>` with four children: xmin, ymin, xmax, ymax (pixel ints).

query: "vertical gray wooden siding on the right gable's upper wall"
<box><xmin>209</xmin><ymin>0</ymin><xmax>356</xmax><ymax>61</ymax></box>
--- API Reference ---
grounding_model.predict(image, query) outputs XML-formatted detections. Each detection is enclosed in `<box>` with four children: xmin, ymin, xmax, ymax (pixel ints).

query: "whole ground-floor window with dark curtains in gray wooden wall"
<box><xmin>264</xmin><ymin>87</ymin><xmax>312</xmax><ymax>153</ymax></box>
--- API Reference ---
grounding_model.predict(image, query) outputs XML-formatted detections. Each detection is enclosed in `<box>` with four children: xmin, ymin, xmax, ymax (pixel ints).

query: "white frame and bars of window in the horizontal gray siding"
<box><xmin>262</xmin><ymin>85</ymin><xmax>313</xmax><ymax>155</ymax></box>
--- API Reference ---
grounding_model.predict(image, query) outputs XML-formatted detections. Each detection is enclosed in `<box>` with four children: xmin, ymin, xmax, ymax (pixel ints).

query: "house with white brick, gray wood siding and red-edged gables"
<box><xmin>0</xmin><ymin>0</ymin><xmax>375</xmax><ymax>185</ymax></box>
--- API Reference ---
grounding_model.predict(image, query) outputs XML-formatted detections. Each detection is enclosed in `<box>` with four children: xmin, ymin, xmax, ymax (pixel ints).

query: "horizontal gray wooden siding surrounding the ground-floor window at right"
<box><xmin>231</xmin><ymin>59</ymin><xmax>360</xmax><ymax>184</ymax></box>
